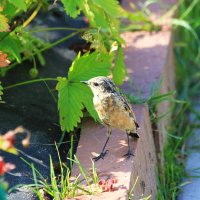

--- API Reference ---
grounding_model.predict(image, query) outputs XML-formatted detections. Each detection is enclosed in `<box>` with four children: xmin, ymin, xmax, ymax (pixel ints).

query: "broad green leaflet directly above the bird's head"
<box><xmin>68</xmin><ymin>52</ymin><xmax>113</xmax><ymax>81</ymax></box>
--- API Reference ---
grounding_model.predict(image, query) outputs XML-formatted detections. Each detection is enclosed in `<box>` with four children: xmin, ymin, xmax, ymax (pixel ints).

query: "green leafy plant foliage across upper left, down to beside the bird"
<box><xmin>0</xmin><ymin>0</ymin><xmax>150</xmax><ymax>132</ymax></box>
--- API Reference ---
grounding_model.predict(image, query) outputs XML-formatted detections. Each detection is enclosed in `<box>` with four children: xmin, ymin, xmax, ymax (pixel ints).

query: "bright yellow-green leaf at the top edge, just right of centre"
<box><xmin>92</xmin><ymin>0</ymin><xmax>121</xmax><ymax>18</ymax></box>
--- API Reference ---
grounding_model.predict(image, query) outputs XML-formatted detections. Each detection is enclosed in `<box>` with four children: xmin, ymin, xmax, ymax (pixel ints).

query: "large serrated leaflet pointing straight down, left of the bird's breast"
<box><xmin>56</xmin><ymin>78</ymin><xmax>83</xmax><ymax>132</ymax></box>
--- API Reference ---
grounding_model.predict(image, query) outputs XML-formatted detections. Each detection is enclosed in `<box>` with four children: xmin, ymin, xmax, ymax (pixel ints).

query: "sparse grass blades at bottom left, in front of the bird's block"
<box><xmin>16</xmin><ymin>146</ymin><xmax>101</xmax><ymax>200</ymax></box>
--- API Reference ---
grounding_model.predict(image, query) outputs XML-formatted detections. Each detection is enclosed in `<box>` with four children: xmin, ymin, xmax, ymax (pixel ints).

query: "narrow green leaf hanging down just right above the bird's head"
<box><xmin>113</xmin><ymin>45</ymin><xmax>126</xmax><ymax>85</ymax></box>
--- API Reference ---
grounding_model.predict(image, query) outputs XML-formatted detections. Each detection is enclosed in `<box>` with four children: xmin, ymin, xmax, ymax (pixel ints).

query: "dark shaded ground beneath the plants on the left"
<box><xmin>0</xmin><ymin>4</ymin><xmax>86</xmax><ymax>200</ymax></box>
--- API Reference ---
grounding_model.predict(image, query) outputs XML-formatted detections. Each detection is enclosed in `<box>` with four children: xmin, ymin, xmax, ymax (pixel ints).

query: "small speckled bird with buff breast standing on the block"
<box><xmin>81</xmin><ymin>76</ymin><xmax>139</xmax><ymax>161</ymax></box>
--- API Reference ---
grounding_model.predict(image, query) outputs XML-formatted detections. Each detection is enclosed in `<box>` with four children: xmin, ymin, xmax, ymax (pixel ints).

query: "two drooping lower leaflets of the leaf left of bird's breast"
<box><xmin>56</xmin><ymin>78</ymin><xmax>100</xmax><ymax>132</ymax></box>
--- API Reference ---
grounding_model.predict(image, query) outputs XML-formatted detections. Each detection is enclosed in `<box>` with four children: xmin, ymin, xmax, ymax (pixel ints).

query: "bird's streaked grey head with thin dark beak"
<box><xmin>81</xmin><ymin>76</ymin><xmax>116</xmax><ymax>95</ymax></box>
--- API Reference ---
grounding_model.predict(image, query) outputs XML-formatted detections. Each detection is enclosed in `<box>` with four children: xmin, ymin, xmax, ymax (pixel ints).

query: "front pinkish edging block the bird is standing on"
<box><xmin>72</xmin><ymin>105</ymin><xmax>156</xmax><ymax>200</ymax></box>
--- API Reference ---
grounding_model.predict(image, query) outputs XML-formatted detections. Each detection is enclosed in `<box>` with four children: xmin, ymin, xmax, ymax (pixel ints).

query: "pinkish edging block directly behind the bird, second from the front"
<box><xmin>122</xmin><ymin>31</ymin><xmax>175</xmax><ymax>158</ymax></box>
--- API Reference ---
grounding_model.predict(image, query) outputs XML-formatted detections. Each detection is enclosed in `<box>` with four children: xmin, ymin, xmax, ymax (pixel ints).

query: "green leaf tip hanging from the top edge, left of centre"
<box><xmin>61</xmin><ymin>0</ymin><xmax>83</xmax><ymax>18</ymax></box>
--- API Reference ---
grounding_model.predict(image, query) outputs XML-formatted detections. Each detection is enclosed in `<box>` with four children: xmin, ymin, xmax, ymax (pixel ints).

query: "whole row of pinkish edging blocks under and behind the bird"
<box><xmin>72</xmin><ymin>0</ymin><xmax>177</xmax><ymax>199</ymax></box>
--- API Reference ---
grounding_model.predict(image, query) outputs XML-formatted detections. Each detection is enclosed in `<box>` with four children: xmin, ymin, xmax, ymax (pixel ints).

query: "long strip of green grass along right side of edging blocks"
<box><xmin>157</xmin><ymin>0</ymin><xmax>200</xmax><ymax>200</ymax></box>
